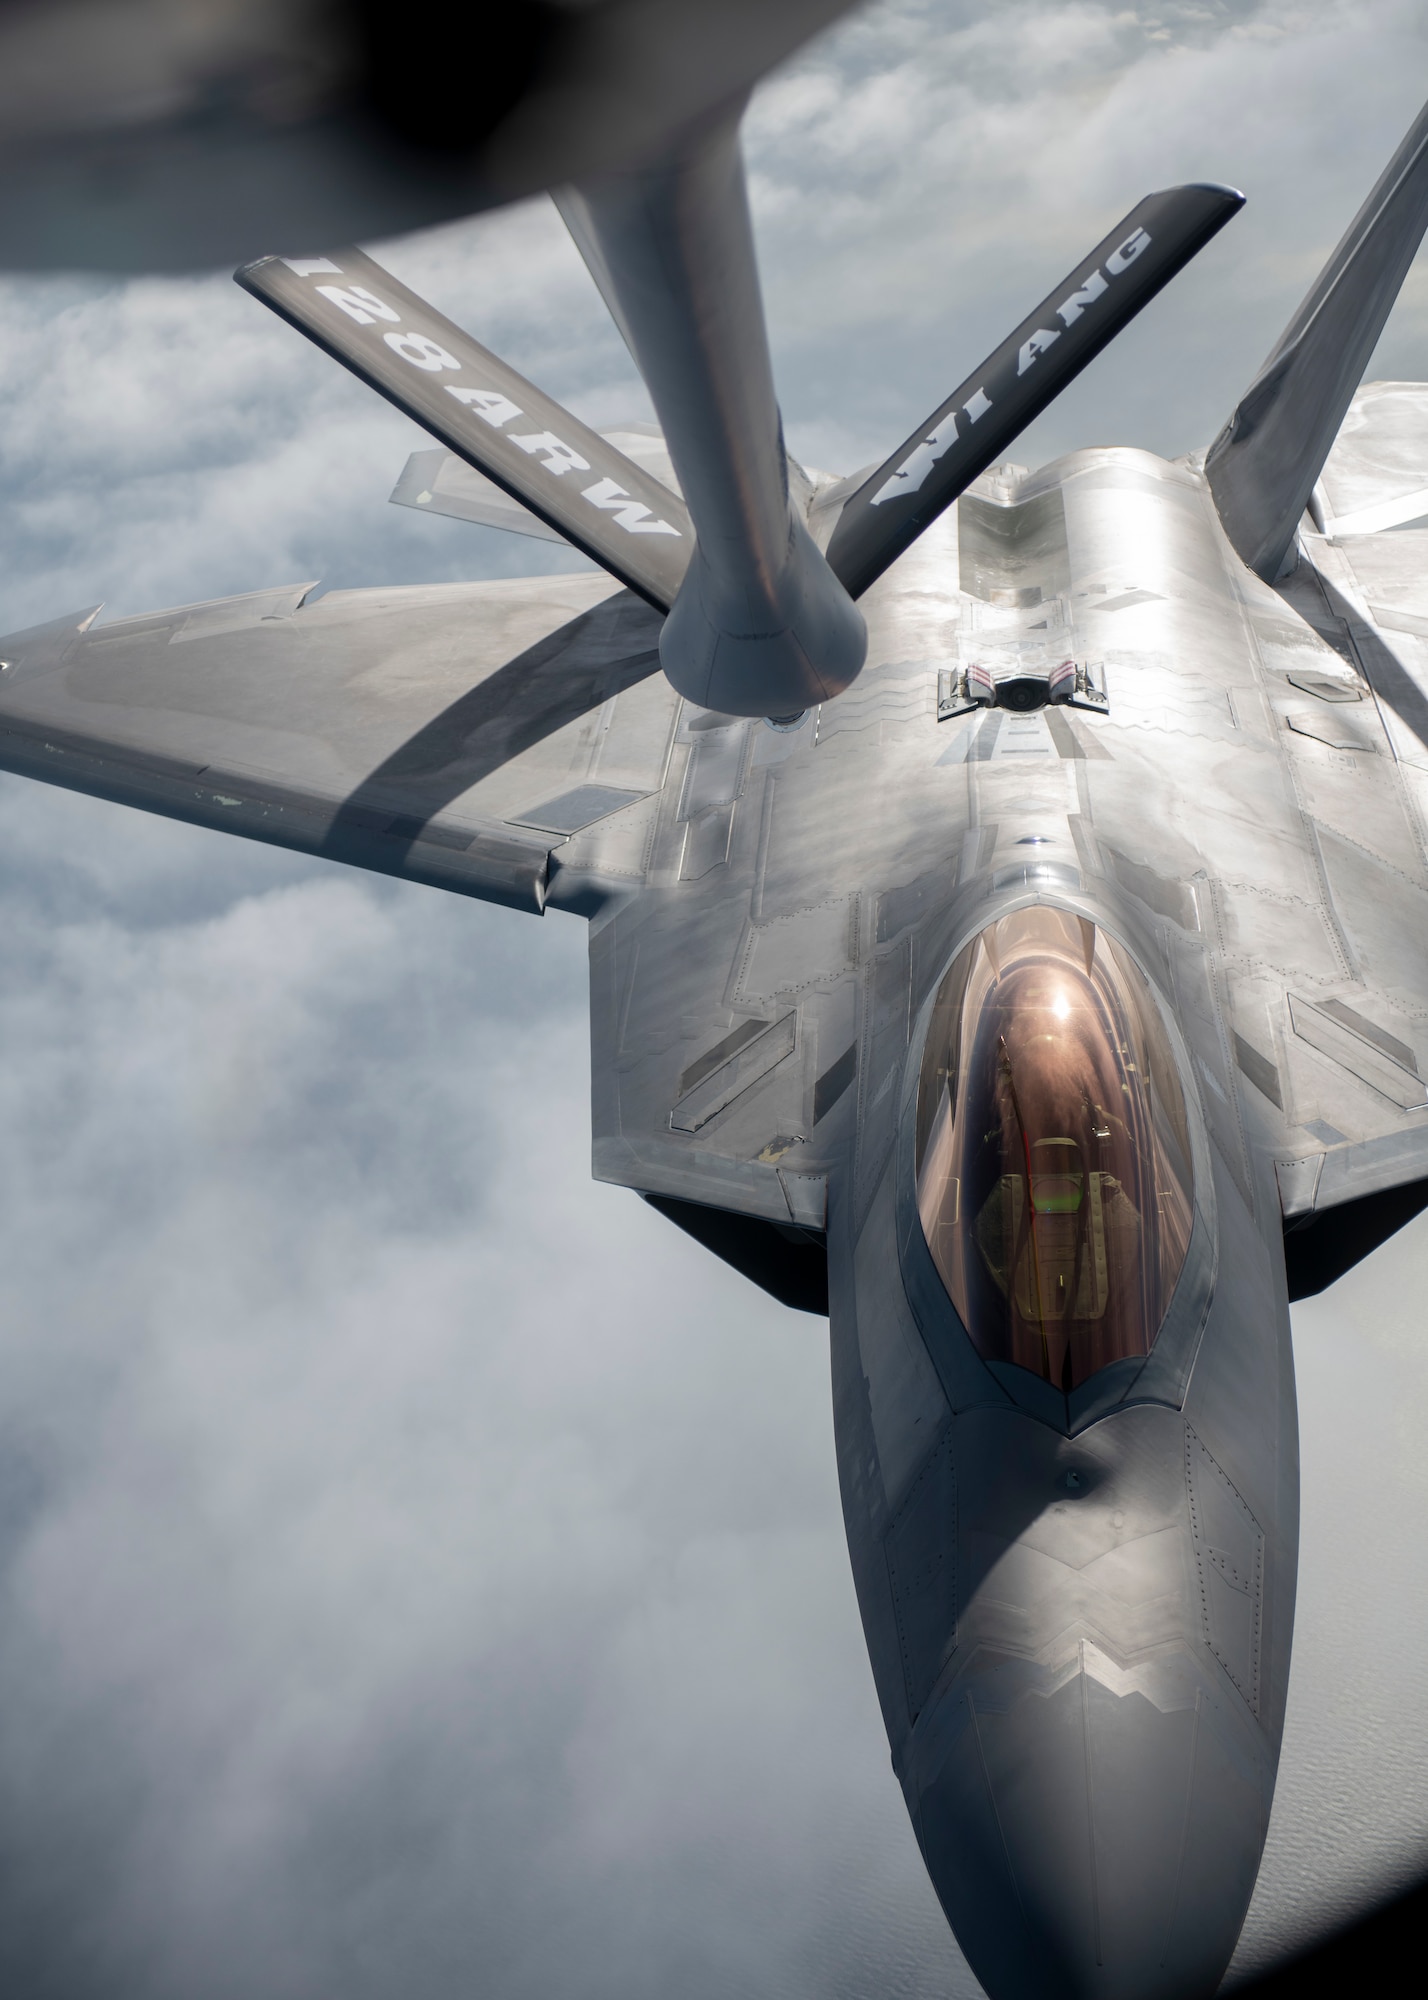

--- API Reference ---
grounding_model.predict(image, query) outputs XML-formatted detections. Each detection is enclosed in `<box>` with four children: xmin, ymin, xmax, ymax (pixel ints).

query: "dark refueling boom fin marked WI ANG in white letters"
<box><xmin>828</xmin><ymin>186</ymin><xmax>1244</xmax><ymax>598</ymax></box>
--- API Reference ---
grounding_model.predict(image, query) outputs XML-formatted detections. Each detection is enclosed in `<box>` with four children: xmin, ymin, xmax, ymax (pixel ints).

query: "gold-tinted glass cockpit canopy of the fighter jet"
<box><xmin>916</xmin><ymin>908</ymin><xmax>1192</xmax><ymax>1390</ymax></box>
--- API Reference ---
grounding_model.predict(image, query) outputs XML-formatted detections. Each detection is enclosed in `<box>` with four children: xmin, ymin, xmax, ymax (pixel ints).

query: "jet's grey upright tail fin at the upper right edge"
<box><xmin>1204</xmin><ymin>106</ymin><xmax>1428</xmax><ymax>582</ymax></box>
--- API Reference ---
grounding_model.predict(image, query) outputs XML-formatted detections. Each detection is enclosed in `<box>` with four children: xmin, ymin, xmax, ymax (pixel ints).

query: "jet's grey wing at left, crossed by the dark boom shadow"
<box><xmin>0</xmin><ymin>574</ymin><xmax>678</xmax><ymax>912</ymax></box>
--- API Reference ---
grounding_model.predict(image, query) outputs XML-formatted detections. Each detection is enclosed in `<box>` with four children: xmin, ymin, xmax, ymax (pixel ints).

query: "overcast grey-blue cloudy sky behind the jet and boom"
<box><xmin>0</xmin><ymin>0</ymin><xmax>1428</xmax><ymax>2000</ymax></box>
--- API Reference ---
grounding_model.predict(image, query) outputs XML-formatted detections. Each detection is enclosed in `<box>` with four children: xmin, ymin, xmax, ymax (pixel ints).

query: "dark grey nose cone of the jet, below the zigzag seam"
<box><xmin>916</xmin><ymin>1644</ymin><xmax>1272</xmax><ymax>2000</ymax></box>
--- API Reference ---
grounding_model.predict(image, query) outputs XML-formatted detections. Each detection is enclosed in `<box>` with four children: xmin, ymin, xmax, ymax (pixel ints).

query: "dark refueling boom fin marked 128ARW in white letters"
<box><xmin>234</xmin><ymin>250</ymin><xmax>694</xmax><ymax>612</ymax></box>
